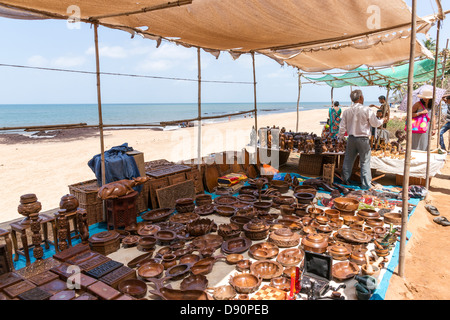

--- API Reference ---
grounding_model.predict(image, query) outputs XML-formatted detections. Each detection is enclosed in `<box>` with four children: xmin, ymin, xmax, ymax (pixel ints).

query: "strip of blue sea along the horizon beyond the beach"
<box><xmin>0</xmin><ymin>101</ymin><xmax>378</xmax><ymax>133</ymax></box>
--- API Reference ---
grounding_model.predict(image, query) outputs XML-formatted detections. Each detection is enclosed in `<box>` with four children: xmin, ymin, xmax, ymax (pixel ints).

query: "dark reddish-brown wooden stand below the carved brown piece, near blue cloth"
<box><xmin>106</xmin><ymin>191</ymin><xmax>138</xmax><ymax>230</ymax></box>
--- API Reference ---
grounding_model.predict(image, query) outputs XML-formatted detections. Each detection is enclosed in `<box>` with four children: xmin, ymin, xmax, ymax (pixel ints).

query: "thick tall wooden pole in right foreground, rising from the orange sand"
<box><xmin>398</xmin><ymin>0</ymin><xmax>417</xmax><ymax>277</ymax></box>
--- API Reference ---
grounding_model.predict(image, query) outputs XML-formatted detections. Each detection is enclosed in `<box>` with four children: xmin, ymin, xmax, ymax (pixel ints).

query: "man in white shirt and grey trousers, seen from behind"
<box><xmin>339</xmin><ymin>90</ymin><xmax>387</xmax><ymax>189</ymax></box>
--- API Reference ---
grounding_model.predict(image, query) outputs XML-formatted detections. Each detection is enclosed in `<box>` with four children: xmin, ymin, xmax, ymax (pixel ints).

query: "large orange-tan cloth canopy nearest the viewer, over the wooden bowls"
<box><xmin>0</xmin><ymin>0</ymin><xmax>436</xmax><ymax>70</ymax></box>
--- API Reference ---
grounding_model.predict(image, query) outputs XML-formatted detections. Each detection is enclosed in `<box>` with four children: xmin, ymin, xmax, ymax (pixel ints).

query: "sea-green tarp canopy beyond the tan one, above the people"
<box><xmin>304</xmin><ymin>59</ymin><xmax>442</xmax><ymax>88</ymax></box>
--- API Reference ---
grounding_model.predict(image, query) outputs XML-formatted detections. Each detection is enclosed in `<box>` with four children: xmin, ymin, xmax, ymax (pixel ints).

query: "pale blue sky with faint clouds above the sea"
<box><xmin>0</xmin><ymin>0</ymin><xmax>450</xmax><ymax>104</ymax></box>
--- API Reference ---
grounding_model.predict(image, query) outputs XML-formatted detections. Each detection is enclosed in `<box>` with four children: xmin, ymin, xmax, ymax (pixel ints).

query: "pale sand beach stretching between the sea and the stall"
<box><xmin>0</xmin><ymin>109</ymin><xmax>328</xmax><ymax>222</ymax></box>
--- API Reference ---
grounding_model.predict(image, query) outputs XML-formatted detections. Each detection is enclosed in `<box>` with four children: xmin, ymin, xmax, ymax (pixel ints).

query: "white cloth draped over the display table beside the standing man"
<box><xmin>370</xmin><ymin>150</ymin><xmax>447</xmax><ymax>179</ymax></box>
